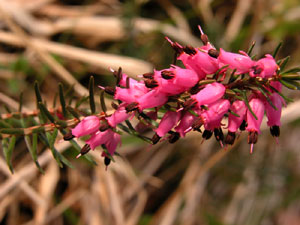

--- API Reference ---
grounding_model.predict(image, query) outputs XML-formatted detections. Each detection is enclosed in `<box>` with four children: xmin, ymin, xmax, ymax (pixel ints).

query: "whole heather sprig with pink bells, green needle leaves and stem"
<box><xmin>0</xmin><ymin>27</ymin><xmax>300</xmax><ymax>170</ymax></box>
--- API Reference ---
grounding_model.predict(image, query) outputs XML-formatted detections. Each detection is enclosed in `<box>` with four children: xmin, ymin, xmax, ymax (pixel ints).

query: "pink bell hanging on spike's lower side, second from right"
<box><xmin>247</xmin><ymin>98</ymin><xmax>265</xmax><ymax>133</ymax></box>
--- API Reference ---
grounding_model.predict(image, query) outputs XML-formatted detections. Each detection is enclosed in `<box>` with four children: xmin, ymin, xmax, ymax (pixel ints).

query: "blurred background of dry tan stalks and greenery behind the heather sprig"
<box><xmin>0</xmin><ymin>0</ymin><xmax>300</xmax><ymax>225</ymax></box>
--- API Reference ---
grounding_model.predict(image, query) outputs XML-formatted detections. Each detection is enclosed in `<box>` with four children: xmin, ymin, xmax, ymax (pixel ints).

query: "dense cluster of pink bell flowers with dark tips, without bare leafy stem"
<box><xmin>64</xmin><ymin>26</ymin><xmax>296</xmax><ymax>165</ymax></box>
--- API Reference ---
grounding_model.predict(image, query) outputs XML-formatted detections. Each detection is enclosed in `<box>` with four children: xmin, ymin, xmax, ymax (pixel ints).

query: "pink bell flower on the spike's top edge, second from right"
<box><xmin>218</xmin><ymin>48</ymin><xmax>254</xmax><ymax>74</ymax></box>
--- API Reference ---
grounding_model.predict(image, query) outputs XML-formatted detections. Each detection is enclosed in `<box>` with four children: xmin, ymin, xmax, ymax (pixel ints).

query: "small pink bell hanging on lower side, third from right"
<box><xmin>228</xmin><ymin>100</ymin><xmax>247</xmax><ymax>133</ymax></box>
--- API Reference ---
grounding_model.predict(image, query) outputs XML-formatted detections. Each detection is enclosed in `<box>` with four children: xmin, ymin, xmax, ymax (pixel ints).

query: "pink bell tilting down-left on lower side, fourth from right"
<box><xmin>201</xmin><ymin>99</ymin><xmax>230</xmax><ymax>131</ymax></box>
